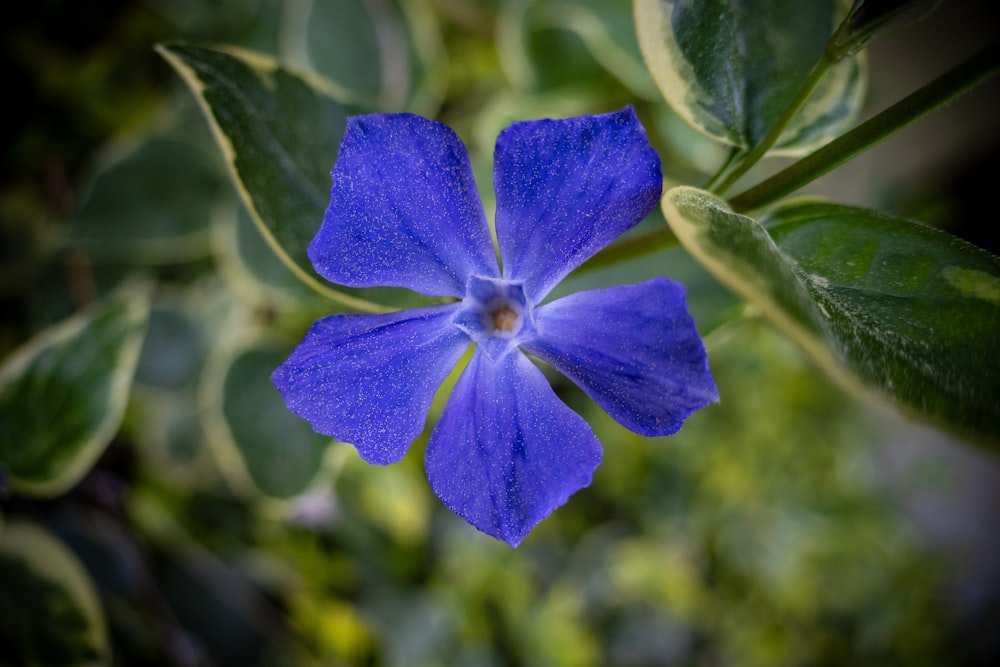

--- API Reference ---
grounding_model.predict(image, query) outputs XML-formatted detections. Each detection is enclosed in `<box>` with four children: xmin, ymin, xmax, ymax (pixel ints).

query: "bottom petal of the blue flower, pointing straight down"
<box><xmin>426</xmin><ymin>350</ymin><xmax>601</xmax><ymax>546</ymax></box>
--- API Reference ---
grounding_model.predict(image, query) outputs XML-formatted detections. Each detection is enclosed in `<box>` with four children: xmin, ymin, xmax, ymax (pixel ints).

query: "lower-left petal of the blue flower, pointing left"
<box><xmin>271</xmin><ymin>304</ymin><xmax>470</xmax><ymax>464</ymax></box>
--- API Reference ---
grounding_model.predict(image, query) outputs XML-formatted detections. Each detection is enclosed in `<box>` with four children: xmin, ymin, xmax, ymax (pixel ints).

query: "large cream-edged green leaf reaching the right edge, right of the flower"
<box><xmin>663</xmin><ymin>187</ymin><xmax>1000</xmax><ymax>448</ymax></box>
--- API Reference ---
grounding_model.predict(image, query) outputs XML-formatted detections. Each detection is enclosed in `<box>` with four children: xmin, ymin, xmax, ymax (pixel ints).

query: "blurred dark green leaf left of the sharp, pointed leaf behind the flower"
<box><xmin>72</xmin><ymin>137</ymin><xmax>226</xmax><ymax>264</ymax></box>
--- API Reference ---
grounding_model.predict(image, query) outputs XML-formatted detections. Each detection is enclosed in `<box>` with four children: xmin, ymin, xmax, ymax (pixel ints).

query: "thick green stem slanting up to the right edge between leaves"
<box><xmin>729</xmin><ymin>41</ymin><xmax>1000</xmax><ymax>212</ymax></box>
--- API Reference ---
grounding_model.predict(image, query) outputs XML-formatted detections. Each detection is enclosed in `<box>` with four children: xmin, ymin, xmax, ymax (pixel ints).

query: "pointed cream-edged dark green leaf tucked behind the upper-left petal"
<box><xmin>157</xmin><ymin>44</ymin><xmax>386</xmax><ymax>312</ymax></box>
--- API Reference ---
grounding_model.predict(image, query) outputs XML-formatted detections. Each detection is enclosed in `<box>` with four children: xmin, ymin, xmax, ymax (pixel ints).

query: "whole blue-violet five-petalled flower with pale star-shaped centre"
<box><xmin>272</xmin><ymin>108</ymin><xmax>718</xmax><ymax>546</ymax></box>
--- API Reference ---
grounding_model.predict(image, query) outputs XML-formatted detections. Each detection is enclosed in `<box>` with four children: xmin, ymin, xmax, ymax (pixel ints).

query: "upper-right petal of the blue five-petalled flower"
<box><xmin>494</xmin><ymin>107</ymin><xmax>662</xmax><ymax>303</ymax></box>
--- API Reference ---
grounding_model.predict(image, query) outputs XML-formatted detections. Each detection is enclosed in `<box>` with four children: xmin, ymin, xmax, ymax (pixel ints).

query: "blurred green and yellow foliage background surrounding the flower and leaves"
<box><xmin>0</xmin><ymin>0</ymin><xmax>1000</xmax><ymax>667</ymax></box>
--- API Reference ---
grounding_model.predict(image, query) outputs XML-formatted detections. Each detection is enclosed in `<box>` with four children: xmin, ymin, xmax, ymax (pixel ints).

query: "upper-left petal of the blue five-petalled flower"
<box><xmin>309</xmin><ymin>114</ymin><xmax>499</xmax><ymax>297</ymax></box>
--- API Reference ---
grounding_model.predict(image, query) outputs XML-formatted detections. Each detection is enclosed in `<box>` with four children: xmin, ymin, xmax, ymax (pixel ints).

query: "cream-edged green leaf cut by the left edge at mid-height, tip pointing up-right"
<box><xmin>0</xmin><ymin>284</ymin><xmax>149</xmax><ymax>496</ymax></box>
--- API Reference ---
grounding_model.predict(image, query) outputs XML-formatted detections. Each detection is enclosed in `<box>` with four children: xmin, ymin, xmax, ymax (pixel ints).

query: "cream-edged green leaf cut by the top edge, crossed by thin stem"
<box><xmin>634</xmin><ymin>0</ymin><xmax>864</xmax><ymax>153</ymax></box>
